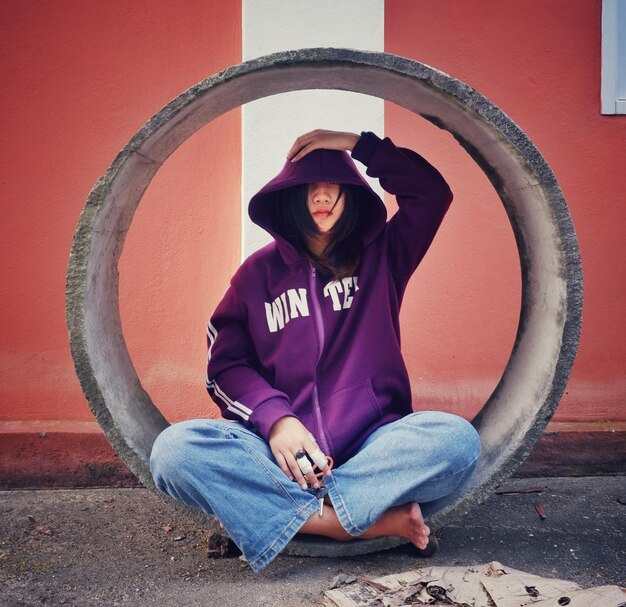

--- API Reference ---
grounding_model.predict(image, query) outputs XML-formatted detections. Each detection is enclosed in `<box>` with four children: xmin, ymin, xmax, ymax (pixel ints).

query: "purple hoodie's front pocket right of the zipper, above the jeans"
<box><xmin>324</xmin><ymin>379</ymin><xmax>382</xmax><ymax>461</ymax></box>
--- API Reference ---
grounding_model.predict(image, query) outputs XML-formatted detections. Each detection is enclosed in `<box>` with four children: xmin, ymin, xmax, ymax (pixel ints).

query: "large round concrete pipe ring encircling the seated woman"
<box><xmin>67</xmin><ymin>48</ymin><xmax>582</xmax><ymax>556</ymax></box>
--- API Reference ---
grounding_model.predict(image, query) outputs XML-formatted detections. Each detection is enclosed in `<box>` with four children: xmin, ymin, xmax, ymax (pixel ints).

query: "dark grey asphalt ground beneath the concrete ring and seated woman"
<box><xmin>0</xmin><ymin>476</ymin><xmax>626</xmax><ymax>607</ymax></box>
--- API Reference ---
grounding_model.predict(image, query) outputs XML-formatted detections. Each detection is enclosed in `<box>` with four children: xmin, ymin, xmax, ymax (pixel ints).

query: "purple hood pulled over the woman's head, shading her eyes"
<box><xmin>248</xmin><ymin>150</ymin><xmax>387</xmax><ymax>258</ymax></box>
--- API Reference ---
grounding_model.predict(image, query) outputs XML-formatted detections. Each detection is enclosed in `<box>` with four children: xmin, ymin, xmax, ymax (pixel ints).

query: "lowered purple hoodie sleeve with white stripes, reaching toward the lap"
<box><xmin>206</xmin><ymin>286</ymin><xmax>295</xmax><ymax>441</ymax></box>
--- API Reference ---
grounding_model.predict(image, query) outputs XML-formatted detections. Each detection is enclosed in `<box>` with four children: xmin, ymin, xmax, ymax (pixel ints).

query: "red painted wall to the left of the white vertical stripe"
<box><xmin>0</xmin><ymin>0</ymin><xmax>241</xmax><ymax>430</ymax></box>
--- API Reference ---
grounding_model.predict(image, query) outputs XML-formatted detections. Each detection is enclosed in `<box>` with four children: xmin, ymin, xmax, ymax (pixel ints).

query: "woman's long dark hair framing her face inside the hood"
<box><xmin>274</xmin><ymin>184</ymin><xmax>363</xmax><ymax>280</ymax></box>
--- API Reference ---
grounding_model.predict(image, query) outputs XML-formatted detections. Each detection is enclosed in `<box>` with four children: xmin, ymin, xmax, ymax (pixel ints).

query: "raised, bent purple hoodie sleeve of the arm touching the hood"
<box><xmin>352</xmin><ymin>133</ymin><xmax>452</xmax><ymax>284</ymax></box>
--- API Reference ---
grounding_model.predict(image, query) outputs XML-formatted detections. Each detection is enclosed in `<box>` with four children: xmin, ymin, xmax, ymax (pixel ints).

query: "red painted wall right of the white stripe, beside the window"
<box><xmin>385</xmin><ymin>0</ymin><xmax>626</xmax><ymax>421</ymax></box>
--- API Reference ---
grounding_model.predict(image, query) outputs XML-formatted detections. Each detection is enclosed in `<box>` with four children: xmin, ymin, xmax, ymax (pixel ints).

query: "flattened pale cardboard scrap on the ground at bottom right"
<box><xmin>323</xmin><ymin>561</ymin><xmax>626</xmax><ymax>607</ymax></box>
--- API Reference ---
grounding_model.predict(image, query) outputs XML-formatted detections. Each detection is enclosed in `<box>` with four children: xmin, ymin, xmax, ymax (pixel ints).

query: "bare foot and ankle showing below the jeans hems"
<box><xmin>300</xmin><ymin>503</ymin><xmax>430</xmax><ymax>550</ymax></box>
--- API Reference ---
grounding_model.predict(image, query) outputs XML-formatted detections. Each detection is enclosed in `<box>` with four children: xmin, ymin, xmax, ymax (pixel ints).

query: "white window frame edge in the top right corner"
<box><xmin>601</xmin><ymin>0</ymin><xmax>626</xmax><ymax>114</ymax></box>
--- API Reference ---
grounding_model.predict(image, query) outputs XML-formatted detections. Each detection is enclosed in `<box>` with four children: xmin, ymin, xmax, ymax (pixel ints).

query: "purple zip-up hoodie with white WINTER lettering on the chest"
<box><xmin>207</xmin><ymin>133</ymin><xmax>452</xmax><ymax>465</ymax></box>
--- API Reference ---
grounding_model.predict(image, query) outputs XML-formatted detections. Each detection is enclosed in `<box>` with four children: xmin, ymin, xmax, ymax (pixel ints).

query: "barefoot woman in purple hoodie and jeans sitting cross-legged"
<box><xmin>151</xmin><ymin>130</ymin><xmax>480</xmax><ymax>571</ymax></box>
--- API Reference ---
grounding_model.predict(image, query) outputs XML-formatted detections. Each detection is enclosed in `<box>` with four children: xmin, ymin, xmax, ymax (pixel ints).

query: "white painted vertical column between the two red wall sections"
<box><xmin>241</xmin><ymin>0</ymin><xmax>384</xmax><ymax>259</ymax></box>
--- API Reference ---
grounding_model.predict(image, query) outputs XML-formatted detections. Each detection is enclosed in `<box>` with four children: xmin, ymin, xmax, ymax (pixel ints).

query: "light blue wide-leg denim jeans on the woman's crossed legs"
<box><xmin>150</xmin><ymin>411</ymin><xmax>480</xmax><ymax>572</ymax></box>
